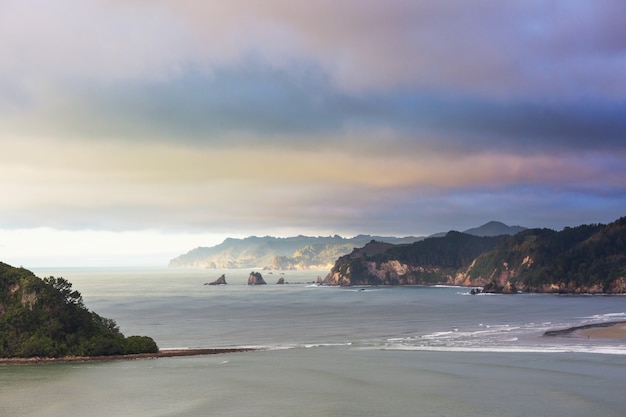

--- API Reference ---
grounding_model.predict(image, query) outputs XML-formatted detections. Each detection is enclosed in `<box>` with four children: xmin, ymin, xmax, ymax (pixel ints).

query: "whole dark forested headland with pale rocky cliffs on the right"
<box><xmin>324</xmin><ymin>217</ymin><xmax>626</xmax><ymax>294</ymax></box>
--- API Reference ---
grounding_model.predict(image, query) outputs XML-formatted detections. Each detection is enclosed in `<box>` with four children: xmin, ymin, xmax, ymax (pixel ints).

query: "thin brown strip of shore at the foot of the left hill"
<box><xmin>0</xmin><ymin>348</ymin><xmax>259</xmax><ymax>365</ymax></box>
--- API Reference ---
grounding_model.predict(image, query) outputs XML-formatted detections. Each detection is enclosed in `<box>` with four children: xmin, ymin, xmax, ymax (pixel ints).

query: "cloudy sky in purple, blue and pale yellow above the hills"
<box><xmin>0</xmin><ymin>0</ymin><xmax>626</xmax><ymax>267</ymax></box>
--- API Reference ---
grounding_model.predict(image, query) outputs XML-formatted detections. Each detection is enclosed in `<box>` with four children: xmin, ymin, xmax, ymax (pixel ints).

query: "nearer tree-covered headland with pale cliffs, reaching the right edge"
<box><xmin>470</xmin><ymin>217</ymin><xmax>626</xmax><ymax>293</ymax></box>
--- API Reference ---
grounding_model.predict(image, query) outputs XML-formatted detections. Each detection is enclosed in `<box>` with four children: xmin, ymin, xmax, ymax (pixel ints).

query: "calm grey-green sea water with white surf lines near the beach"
<box><xmin>0</xmin><ymin>268</ymin><xmax>626</xmax><ymax>417</ymax></box>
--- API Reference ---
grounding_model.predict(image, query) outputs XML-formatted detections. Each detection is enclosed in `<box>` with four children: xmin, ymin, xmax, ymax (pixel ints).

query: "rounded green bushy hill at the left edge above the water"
<box><xmin>0</xmin><ymin>262</ymin><xmax>158</xmax><ymax>357</ymax></box>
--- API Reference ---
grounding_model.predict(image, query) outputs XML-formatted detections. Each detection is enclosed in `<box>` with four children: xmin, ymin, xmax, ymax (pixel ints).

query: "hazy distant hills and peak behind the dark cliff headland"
<box><xmin>169</xmin><ymin>221</ymin><xmax>525</xmax><ymax>270</ymax></box>
